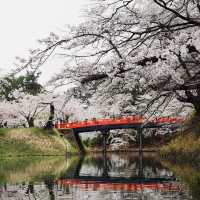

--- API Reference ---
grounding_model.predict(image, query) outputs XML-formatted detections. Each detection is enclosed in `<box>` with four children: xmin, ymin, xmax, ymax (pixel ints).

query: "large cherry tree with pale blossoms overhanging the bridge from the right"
<box><xmin>11</xmin><ymin>0</ymin><xmax>200</xmax><ymax>117</ymax></box>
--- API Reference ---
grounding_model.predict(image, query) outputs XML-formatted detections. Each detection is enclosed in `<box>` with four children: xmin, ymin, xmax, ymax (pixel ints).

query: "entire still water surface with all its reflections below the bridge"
<box><xmin>0</xmin><ymin>153</ymin><xmax>200</xmax><ymax>200</ymax></box>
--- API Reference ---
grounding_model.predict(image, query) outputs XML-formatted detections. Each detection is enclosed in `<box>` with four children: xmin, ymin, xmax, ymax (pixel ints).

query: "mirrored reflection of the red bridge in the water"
<box><xmin>56</xmin><ymin>153</ymin><xmax>181</xmax><ymax>198</ymax></box>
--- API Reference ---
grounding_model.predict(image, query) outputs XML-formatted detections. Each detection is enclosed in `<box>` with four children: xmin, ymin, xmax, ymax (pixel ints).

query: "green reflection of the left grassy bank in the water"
<box><xmin>0</xmin><ymin>156</ymin><xmax>67</xmax><ymax>185</ymax></box>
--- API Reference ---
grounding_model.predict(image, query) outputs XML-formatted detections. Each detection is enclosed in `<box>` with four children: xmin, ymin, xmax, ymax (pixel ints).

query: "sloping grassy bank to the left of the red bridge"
<box><xmin>0</xmin><ymin>128</ymin><xmax>66</xmax><ymax>157</ymax></box>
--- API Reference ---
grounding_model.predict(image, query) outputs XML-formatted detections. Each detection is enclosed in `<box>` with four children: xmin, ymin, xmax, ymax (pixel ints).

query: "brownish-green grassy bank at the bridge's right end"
<box><xmin>160</xmin><ymin>114</ymin><xmax>200</xmax><ymax>162</ymax></box>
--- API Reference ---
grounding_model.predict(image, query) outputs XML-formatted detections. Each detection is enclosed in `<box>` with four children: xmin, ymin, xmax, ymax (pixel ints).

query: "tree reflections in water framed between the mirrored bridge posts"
<box><xmin>77</xmin><ymin>154</ymin><xmax>169</xmax><ymax>177</ymax></box>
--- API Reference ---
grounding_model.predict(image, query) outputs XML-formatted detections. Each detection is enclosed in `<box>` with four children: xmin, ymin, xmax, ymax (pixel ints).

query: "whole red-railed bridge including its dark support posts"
<box><xmin>55</xmin><ymin>115</ymin><xmax>184</xmax><ymax>153</ymax></box>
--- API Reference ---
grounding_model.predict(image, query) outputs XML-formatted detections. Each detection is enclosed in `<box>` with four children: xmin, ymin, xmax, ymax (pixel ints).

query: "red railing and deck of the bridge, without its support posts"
<box><xmin>55</xmin><ymin>116</ymin><xmax>184</xmax><ymax>133</ymax></box>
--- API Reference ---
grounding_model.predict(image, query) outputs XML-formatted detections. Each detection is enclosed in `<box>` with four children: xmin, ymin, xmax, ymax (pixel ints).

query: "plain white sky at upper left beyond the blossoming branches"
<box><xmin>0</xmin><ymin>0</ymin><xmax>89</xmax><ymax>82</ymax></box>
